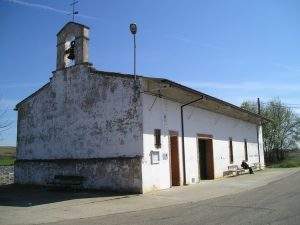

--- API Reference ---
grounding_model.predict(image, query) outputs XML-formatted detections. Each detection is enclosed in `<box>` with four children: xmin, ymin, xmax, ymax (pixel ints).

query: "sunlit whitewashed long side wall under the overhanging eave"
<box><xmin>142</xmin><ymin>94</ymin><xmax>263</xmax><ymax>192</ymax></box>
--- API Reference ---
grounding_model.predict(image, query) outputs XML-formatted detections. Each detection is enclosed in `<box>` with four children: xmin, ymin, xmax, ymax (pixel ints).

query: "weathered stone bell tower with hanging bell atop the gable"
<box><xmin>56</xmin><ymin>22</ymin><xmax>89</xmax><ymax>70</ymax></box>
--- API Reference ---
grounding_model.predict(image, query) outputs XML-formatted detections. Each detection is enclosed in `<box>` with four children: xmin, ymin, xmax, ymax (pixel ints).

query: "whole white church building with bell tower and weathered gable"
<box><xmin>15</xmin><ymin>22</ymin><xmax>264</xmax><ymax>193</ymax></box>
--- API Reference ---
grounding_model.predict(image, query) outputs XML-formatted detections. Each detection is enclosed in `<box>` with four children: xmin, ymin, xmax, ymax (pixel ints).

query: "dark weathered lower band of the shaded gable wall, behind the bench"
<box><xmin>15</xmin><ymin>157</ymin><xmax>142</xmax><ymax>193</ymax></box>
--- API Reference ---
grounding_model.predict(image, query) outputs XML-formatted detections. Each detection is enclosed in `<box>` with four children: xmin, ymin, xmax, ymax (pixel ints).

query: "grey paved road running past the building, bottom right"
<box><xmin>48</xmin><ymin>172</ymin><xmax>300</xmax><ymax>225</ymax></box>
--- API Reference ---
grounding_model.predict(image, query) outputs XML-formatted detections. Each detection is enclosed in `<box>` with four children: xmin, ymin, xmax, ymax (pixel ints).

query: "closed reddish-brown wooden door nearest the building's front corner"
<box><xmin>170</xmin><ymin>136</ymin><xmax>180</xmax><ymax>186</ymax></box>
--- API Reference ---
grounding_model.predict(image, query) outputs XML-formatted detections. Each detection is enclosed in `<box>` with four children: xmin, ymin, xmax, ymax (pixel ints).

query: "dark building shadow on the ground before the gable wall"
<box><xmin>0</xmin><ymin>184</ymin><xmax>135</xmax><ymax>207</ymax></box>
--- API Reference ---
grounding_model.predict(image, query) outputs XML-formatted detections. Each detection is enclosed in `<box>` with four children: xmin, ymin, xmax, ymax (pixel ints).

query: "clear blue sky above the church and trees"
<box><xmin>0</xmin><ymin>0</ymin><xmax>300</xmax><ymax>145</ymax></box>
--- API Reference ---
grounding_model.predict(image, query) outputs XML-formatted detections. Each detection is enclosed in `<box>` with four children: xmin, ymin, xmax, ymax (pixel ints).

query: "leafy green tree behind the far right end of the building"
<box><xmin>241</xmin><ymin>99</ymin><xmax>300</xmax><ymax>156</ymax></box>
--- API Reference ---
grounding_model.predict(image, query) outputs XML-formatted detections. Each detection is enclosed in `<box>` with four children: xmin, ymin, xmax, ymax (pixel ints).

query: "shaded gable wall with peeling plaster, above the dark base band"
<box><xmin>17</xmin><ymin>65</ymin><xmax>143</xmax><ymax>159</ymax></box>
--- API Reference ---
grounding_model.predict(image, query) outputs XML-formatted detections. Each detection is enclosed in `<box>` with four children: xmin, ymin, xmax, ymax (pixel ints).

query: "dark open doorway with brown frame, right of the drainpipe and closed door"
<box><xmin>198</xmin><ymin>137</ymin><xmax>214</xmax><ymax>180</ymax></box>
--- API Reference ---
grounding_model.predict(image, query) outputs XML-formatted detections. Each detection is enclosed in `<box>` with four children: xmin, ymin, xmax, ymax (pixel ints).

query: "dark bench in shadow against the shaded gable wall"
<box><xmin>48</xmin><ymin>175</ymin><xmax>85</xmax><ymax>189</ymax></box>
